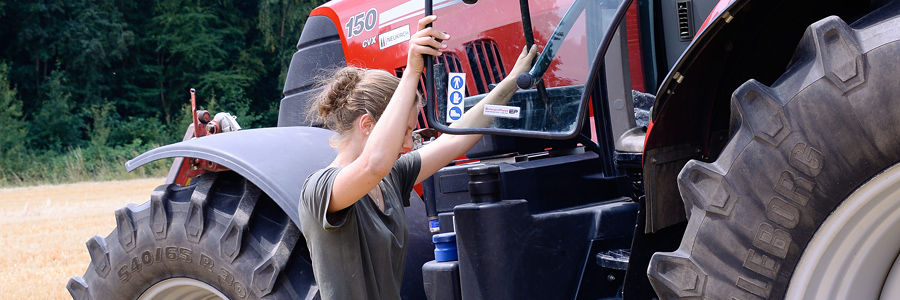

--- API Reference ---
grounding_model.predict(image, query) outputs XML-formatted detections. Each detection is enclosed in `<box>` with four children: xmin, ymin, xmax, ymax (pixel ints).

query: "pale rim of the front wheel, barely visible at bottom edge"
<box><xmin>138</xmin><ymin>278</ymin><xmax>228</xmax><ymax>300</ymax></box>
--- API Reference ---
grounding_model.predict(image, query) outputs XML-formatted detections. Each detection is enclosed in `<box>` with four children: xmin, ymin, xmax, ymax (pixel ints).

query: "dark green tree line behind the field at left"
<box><xmin>0</xmin><ymin>0</ymin><xmax>324</xmax><ymax>186</ymax></box>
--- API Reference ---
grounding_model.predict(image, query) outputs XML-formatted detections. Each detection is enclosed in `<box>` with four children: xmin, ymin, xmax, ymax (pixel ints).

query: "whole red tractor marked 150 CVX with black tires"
<box><xmin>67</xmin><ymin>0</ymin><xmax>900</xmax><ymax>300</ymax></box>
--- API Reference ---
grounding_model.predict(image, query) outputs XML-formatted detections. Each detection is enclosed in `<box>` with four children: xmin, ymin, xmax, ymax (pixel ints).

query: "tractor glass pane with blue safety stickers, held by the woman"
<box><xmin>433</xmin><ymin>0</ymin><xmax>623</xmax><ymax>138</ymax></box>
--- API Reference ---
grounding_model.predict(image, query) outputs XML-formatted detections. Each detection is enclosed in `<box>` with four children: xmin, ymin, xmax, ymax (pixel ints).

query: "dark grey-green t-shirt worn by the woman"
<box><xmin>299</xmin><ymin>151</ymin><xmax>421</xmax><ymax>300</ymax></box>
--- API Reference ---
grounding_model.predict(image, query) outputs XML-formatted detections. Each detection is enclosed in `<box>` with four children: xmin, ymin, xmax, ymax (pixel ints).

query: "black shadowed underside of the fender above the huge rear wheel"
<box><xmin>644</xmin><ymin>0</ymin><xmax>886</xmax><ymax>233</ymax></box>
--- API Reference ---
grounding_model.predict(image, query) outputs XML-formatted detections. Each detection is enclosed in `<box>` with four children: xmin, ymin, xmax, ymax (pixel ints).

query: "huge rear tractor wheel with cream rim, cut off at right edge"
<box><xmin>648</xmin><ymin>1</ymin><xmax>900</xmax><ymax>300</ymax></box>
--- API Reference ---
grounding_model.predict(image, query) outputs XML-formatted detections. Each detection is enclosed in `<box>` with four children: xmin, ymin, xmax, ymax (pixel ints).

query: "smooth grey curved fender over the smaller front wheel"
<box><xmin>125</xmin><ymin>127</ymin><xmax>337</xmax><ymax>226</ymax></box>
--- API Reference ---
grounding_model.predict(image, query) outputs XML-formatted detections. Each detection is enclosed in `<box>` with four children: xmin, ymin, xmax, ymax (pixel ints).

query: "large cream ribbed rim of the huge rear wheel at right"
<box><xmin>786</xmin><ymin>164</ymin><xmax>900</xmax><ymax>299</ymax></box>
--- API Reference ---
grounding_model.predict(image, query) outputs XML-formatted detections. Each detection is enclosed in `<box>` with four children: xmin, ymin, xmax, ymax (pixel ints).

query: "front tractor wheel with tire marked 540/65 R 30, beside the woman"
<box><xmin>67</xmin><ymin>172</ymin><xmax>318</xmax><ymax>300</ymax></box>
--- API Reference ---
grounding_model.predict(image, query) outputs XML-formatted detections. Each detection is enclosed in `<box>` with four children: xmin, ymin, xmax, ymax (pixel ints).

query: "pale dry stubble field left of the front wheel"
<box><xmin>0</xmin><ymin>178</ymin><xmax>164</xmax><ymax>299</ymax></box>
